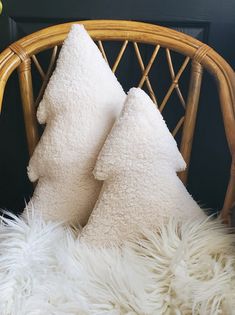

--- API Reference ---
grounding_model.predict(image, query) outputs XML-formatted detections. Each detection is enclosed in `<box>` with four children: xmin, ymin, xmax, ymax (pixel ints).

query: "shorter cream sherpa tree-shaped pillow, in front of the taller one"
<box><xmin>81</xmin><ymin>88</ymin><xmax>205</xmax><ymax>245</ymax></box>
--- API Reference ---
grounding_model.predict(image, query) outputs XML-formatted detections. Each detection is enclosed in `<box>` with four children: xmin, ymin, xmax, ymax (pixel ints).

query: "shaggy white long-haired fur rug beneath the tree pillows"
<box><xmin>0</xmin><ymin>215</ymin><xmax>235</xmax><ymax>315</ymax></box>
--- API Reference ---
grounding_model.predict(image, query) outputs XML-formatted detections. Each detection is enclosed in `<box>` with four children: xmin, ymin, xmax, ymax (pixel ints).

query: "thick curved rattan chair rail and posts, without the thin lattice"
<box><xmin>0</xmin><ymin>20</ymin><xmax>235</xmax><ymax>223</ymax></box>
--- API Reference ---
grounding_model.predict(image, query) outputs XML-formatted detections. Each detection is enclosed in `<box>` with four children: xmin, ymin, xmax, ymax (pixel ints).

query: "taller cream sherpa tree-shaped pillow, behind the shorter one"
<box><xmin>24</xmin><ymin>25</ymin><xmax>126</xmax><ymax>225</ymax></box>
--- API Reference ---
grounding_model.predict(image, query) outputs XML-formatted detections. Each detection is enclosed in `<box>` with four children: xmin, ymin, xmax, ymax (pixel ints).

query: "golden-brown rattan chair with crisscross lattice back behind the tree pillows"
<box><xmin>0</xmin><ymin>20</ymin><xmax>235</xmax><ymax>223</ymax></box>
